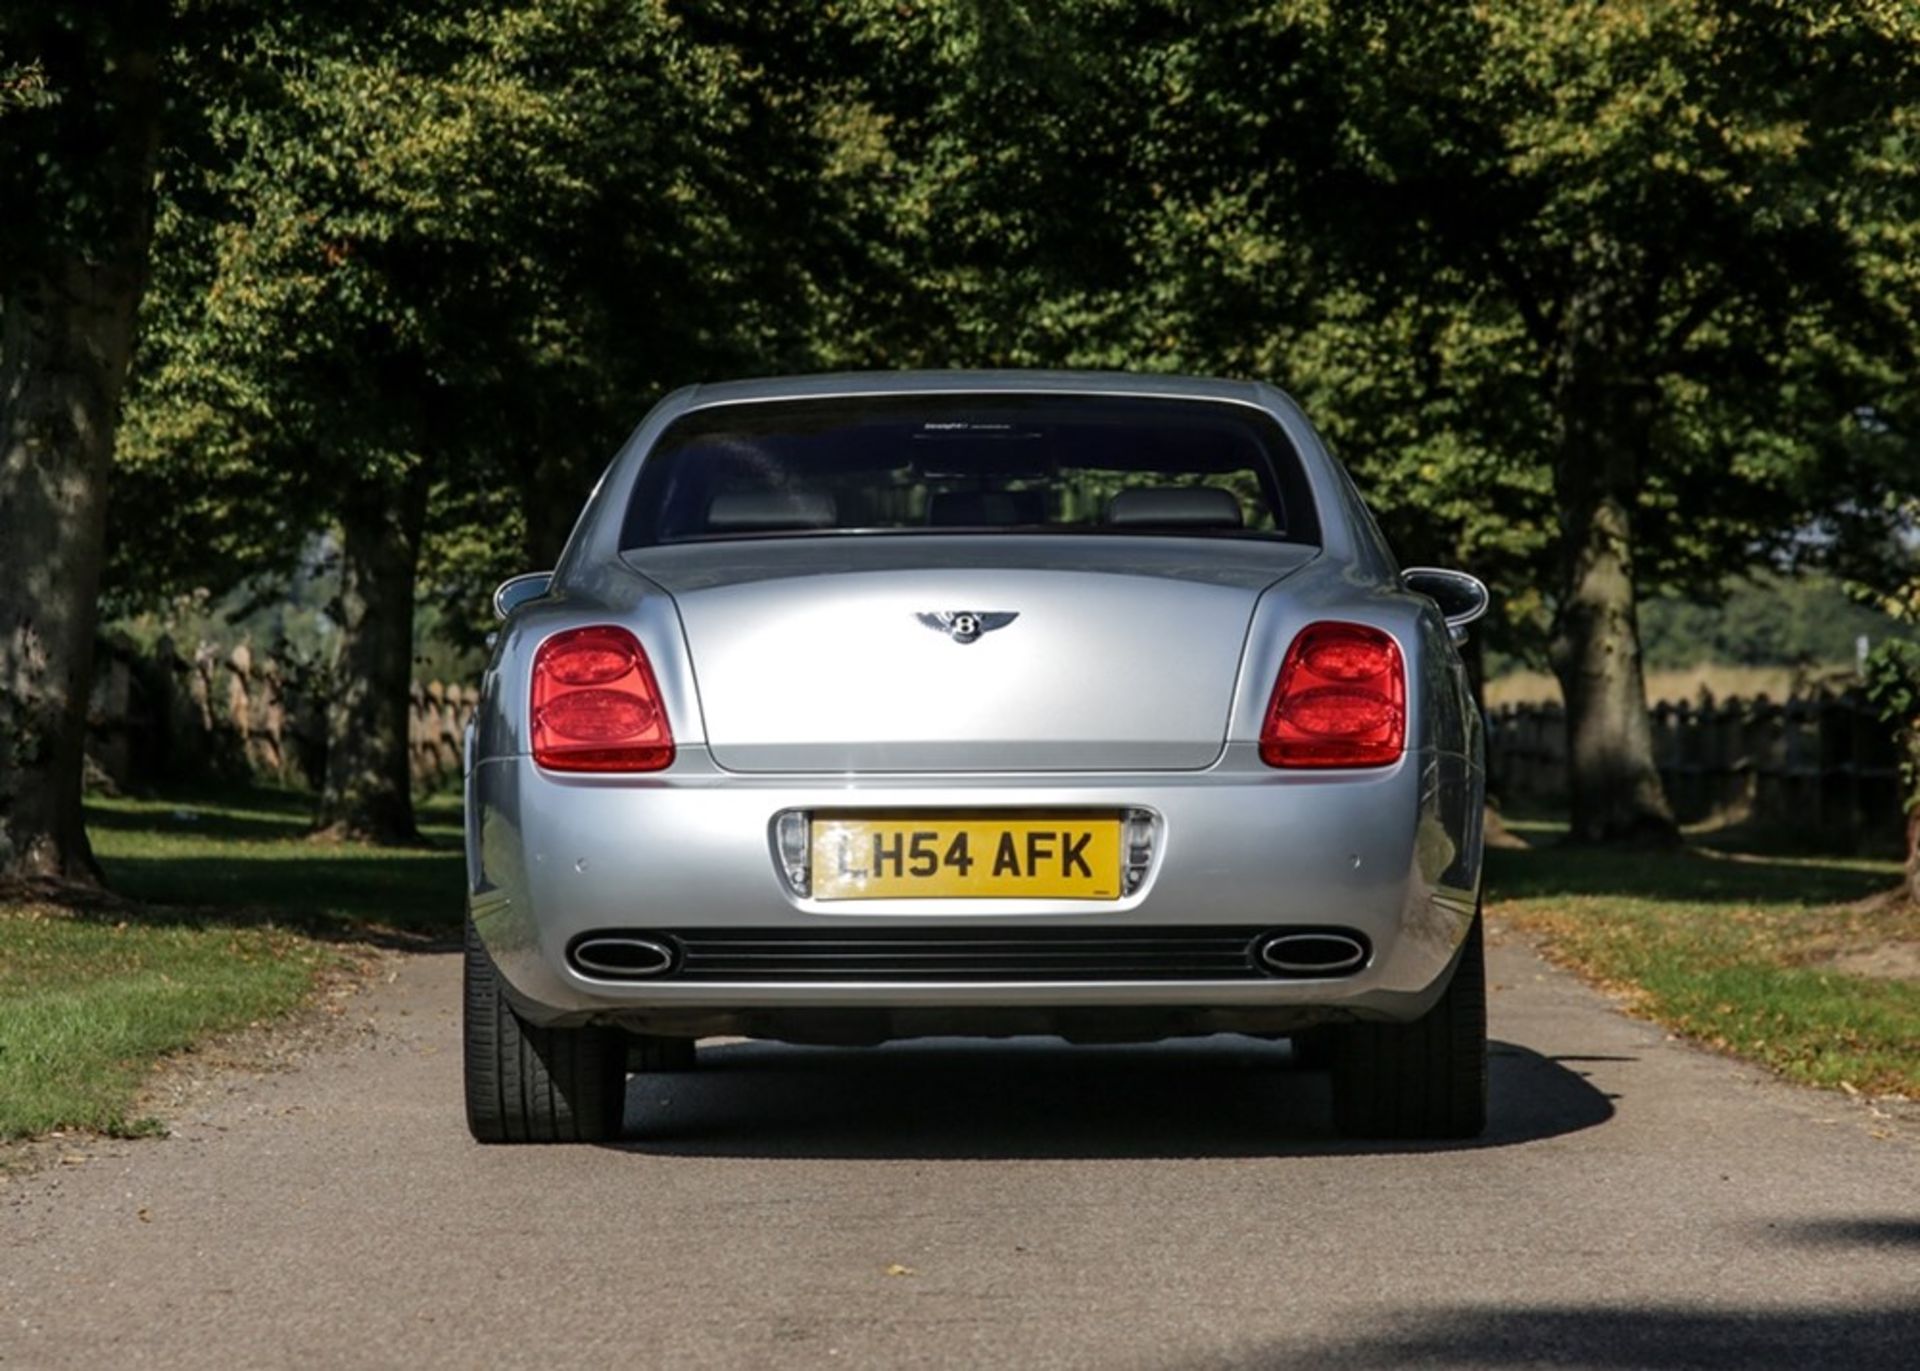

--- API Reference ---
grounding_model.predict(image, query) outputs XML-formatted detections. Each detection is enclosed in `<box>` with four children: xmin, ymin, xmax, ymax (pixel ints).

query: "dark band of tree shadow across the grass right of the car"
<box><xmin>1486</xmin><ymin>843</ymin><xmax>1897</xmax><ymax>904</ymax></box>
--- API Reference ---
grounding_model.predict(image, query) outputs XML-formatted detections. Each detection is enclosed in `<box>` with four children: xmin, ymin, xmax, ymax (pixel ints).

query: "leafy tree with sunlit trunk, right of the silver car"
<box><xmin>1274</xmin><ymin>0</ymin><xmax>1920</xmax><ymax>839</ymax></box>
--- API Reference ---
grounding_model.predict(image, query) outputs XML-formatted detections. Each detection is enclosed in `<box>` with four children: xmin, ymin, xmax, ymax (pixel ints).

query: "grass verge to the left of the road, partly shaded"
<box><xmin>0</xmin><ymin>789</ymin><xmax>461</xmax><ymax>1137</ymax></box>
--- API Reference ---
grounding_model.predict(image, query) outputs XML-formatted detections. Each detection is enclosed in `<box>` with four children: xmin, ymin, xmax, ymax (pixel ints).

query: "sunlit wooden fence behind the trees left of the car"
<box><xmin>86</xmin><ymin>637</ymin><xmax>480</xmax><ymax>789</ymax></box>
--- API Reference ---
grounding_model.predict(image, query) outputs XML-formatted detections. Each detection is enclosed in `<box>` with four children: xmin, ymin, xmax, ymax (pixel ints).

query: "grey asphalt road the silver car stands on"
<box><xmin>0</xmin><ymin>925</ymin><xmax>1920</xmax><ymax>1369</ymax></box>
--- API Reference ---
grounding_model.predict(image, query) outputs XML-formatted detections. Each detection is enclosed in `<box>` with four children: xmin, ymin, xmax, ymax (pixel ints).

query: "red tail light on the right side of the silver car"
<box><xmin>1260</xmin><ymin>624</ymin><xmax>1407</xmax><ymax>768</ymax></box>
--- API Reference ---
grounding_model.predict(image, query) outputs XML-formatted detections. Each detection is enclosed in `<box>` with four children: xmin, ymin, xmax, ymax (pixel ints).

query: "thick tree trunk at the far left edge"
<box><xmin>0</xmin><ymin>35</ymin><xmax>161</xmax><ymax>883</ymax></box>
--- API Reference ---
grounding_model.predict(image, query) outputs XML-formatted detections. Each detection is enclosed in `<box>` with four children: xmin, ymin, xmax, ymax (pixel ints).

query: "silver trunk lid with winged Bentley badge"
<box><xmin>628</xmin><ymin>536</ymin><xmax>1317</xmax><ymax>772</ymax></box>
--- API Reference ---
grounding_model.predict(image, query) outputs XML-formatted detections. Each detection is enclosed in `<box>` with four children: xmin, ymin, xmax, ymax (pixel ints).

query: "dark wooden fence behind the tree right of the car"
<box><xmin>1486</xmin><ymin>691</ymin><xmax>1903</xmax><ymax>851</ymax></box>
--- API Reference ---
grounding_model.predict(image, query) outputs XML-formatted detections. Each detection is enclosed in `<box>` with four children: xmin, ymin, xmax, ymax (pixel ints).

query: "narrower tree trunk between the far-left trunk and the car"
<box><xmin>317</xmin><ymin>469</ymin><xmax>426</xmax><ymax>843</ymax></box>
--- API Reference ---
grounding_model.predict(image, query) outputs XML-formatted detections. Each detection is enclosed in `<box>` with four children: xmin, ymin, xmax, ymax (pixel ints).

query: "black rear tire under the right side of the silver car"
<box><xmin>1332</xmin><ymin>914</ymin><xmax>1486</xmax><ymax>1139</ymax></box>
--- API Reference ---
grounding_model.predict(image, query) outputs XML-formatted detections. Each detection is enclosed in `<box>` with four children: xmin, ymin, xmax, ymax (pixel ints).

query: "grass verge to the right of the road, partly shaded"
<box><xmin>1488</xmin><ymin>824</ymin><xmax>1920</xmax><ymax>1098</ymax></box>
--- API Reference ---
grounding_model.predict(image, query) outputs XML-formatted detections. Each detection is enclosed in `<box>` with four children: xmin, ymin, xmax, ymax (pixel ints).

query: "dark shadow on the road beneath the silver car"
<box><xmin>612</xmin><ymin>1035</ymin><xmax>1613</xmax><ymax>1160</ymax></box>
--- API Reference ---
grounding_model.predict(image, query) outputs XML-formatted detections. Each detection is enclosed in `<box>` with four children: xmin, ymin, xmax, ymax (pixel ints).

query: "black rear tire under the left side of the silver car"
<box><xmin>463</xmin><ymin>920</ymin><xmax>626</xmax><ymax>1143</ymax></box>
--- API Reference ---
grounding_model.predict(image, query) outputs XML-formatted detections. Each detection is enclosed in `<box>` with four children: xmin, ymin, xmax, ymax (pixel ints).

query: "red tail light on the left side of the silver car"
<box><xmin>534</xmin><ymin>624</ymin><xmax>674</xmax><ymax>772</ymax></box>
